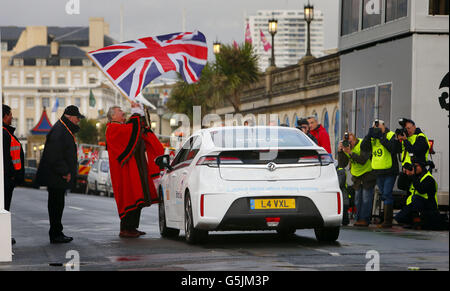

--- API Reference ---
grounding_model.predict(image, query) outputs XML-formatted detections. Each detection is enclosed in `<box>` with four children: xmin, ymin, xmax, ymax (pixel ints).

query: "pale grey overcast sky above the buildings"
<box><xmin>0</xmin><ymin>0</ymin><xmax>339</xmax><ymax>59</ymax></box>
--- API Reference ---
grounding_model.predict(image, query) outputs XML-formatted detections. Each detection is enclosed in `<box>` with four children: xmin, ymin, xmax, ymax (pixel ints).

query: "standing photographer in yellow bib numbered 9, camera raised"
<box><xmin>361</xmin><ymin>120</ymin><xmax>401</xmax><ymax>228</ymax></box>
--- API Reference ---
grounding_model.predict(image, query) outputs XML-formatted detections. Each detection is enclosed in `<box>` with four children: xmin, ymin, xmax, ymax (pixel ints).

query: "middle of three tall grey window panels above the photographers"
<box><xmin>355</xmin><ymin>87</ymin><xmax>375</xmax><ymax>137</ymax></box>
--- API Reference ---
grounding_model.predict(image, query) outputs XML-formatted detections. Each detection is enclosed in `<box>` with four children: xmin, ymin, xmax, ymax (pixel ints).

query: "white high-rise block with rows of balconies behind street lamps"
<box><xmin>248</xmin><ymin>10</ymin><xmax>324</xmax><ymax>71</ymax></box>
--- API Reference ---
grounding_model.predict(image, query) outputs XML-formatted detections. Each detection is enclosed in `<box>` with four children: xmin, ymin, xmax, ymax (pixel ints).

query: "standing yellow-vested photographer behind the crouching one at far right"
<box><xmin>395</xmin><ymin>118</ymin><xmax>430</xmax><ymax>170</ymax></box>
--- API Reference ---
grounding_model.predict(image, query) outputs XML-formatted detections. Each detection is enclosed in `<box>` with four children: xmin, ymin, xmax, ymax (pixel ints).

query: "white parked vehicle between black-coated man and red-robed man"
<box><xmin>86</xmin><ymin>151</ymin><xmax>111</xmax><ymax>195</ymax></box>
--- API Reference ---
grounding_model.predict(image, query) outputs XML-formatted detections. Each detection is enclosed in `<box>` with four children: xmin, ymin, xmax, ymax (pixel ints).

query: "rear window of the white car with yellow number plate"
<box><xmin>210</xmin><ymin>127</ymin><xmax>313</xmax><ymax>148</ymax></box>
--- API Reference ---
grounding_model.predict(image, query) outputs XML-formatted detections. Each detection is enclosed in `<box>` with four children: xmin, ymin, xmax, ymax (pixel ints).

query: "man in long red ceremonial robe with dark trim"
<box><xmin>106</xmin><ymin>103</ymin><xmax>164</xmax><ymax>238</ymax></box>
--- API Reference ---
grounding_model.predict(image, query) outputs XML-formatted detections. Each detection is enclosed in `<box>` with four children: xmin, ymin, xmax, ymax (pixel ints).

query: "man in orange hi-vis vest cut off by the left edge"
<box><xmin>2</xmin><ymin>104</ymin><xmax>25</xmax><ymax>244</ymax></box>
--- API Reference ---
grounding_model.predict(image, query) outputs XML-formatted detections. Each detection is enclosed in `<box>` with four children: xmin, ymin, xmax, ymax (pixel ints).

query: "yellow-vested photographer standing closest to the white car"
<box><xmin>338</xmin><ymin>133</ymin><xmax>376</xmax><ymax>227</ymax></box>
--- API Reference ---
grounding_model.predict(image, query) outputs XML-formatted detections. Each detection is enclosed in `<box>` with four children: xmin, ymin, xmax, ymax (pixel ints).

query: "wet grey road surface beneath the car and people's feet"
<box><xmin>0</xmin><ymin>188</ymin><xmax>449</xmax><ymax>271</ymax></box>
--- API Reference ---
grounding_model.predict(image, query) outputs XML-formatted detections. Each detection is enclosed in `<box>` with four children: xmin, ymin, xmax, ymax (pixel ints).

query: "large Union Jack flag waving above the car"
<box><xmin>87</xmin><ymin>31</ymin><xmax>208</xmax><ymax>100</ymax></box>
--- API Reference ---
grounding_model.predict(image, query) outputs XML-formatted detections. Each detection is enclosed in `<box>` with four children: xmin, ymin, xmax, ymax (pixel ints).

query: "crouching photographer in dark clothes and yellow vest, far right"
<box><xmin>395</xmin><ymin>157</ymin><xmax>444</xmax><ymax>230</ymax></box>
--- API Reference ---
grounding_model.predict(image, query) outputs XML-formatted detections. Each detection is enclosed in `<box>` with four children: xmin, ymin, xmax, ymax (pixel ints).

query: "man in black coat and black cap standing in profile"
<box><xmin>37</xmin><ymin>105</ymin><xmax>84</xmax><ymax>243</ymax></box>
